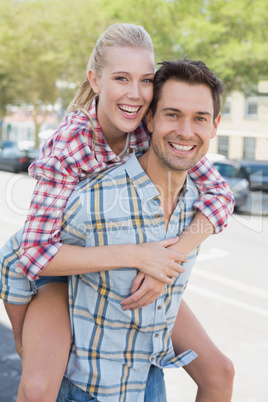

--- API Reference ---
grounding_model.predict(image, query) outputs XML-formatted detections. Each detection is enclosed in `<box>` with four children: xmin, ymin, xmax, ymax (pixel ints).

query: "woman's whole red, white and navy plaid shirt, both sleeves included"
<box><xmin>16</xmin><ymin>100</ymin><xmax>234</xmax><ymax>280</ymax></box>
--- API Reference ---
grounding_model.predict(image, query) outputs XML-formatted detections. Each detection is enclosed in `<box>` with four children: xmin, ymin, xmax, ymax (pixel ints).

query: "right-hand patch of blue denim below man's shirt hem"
<box><xmin>144</xmin><ymin>365</ymin><xmax>167</xmax><ymax>402</ymax></box>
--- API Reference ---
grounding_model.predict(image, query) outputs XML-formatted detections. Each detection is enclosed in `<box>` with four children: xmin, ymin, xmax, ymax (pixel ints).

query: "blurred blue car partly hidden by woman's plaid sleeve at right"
<box><xmin>213</xmin><ymin>159</ymin><xmax>250</xmax><ymax>210</ymax></box>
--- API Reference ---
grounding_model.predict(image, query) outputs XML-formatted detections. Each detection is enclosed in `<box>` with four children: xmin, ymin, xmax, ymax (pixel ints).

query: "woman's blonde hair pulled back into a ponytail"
<box><xmin>67</xmin><ymin>23</ymin><xmax>154</xmax><ymax>114</ymax></box>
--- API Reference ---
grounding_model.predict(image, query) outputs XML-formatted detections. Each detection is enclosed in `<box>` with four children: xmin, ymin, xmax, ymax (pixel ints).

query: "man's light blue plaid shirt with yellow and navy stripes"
<box><xmin>0</xmin><ymin>154</ymin><xmax>198</xmax><ymax>402</ymax></box>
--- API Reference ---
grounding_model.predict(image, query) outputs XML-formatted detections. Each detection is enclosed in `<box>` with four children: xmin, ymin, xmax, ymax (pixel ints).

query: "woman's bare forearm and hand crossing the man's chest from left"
<box><xmin>40</xmin><ymin>238</ymin><xmax>187</xmax><ymax>284</ymax></box>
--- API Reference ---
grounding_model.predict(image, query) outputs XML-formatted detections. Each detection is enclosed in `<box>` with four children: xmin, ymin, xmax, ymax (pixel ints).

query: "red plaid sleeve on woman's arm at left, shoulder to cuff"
<box><xmin>17</xmin><ymin>114</ymin><xmax>100</xmax><ymax>280</ymax></box>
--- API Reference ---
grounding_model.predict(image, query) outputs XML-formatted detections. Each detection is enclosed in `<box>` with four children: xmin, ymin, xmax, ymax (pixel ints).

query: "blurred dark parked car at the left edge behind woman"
<box><xmin>0</xmin><ymin>146</ymin><xmax>34</xmax><ymax>173</ymax></box>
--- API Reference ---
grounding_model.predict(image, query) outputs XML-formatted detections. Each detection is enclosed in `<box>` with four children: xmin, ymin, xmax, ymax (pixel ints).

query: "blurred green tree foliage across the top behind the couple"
<box><xmin>0</xmin><ymin>0</ymin><xmax>268</xmax><ymax>114</ymax></box>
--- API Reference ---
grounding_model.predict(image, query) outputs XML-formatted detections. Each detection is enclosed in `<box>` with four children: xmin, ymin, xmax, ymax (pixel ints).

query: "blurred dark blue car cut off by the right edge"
<box><xmin>241</xmin><ymin>161</ymin><xmax>268</xmax><ymax>191</ymax></box>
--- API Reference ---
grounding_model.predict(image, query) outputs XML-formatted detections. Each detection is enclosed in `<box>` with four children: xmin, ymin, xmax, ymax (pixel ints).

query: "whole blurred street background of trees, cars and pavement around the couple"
<box><xmin>0</xmin><ymin>0</ymin><xmax>268</xmax><ymax>402</ymax></box>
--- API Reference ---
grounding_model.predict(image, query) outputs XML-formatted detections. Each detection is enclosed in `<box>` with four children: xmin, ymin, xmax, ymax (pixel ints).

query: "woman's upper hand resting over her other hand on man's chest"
<box><xmin>135</xmin><ymin>237</ymin><xmax>187</xmax><ymax>286</ymax></box>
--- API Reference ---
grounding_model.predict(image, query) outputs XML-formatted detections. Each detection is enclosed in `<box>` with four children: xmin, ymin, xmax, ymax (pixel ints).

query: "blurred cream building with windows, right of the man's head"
<box><xmin>209</xmin><ymin>81</ymin><xmax>268</xmax><ymax>161</ymax></box>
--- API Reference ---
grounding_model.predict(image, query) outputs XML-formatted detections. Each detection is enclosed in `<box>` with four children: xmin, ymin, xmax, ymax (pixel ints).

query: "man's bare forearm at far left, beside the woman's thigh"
<box><xmin>4</xmin><ymin>301</ymin><xmax>28</xmax><ymax>358</ymax></box>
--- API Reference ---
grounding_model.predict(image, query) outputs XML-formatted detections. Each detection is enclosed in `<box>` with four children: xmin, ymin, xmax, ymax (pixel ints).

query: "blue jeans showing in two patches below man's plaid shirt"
<box><xmin>56</xmin><ymin>366</ymin><xmax>167</xmax><ymax>402</ymax></box>
